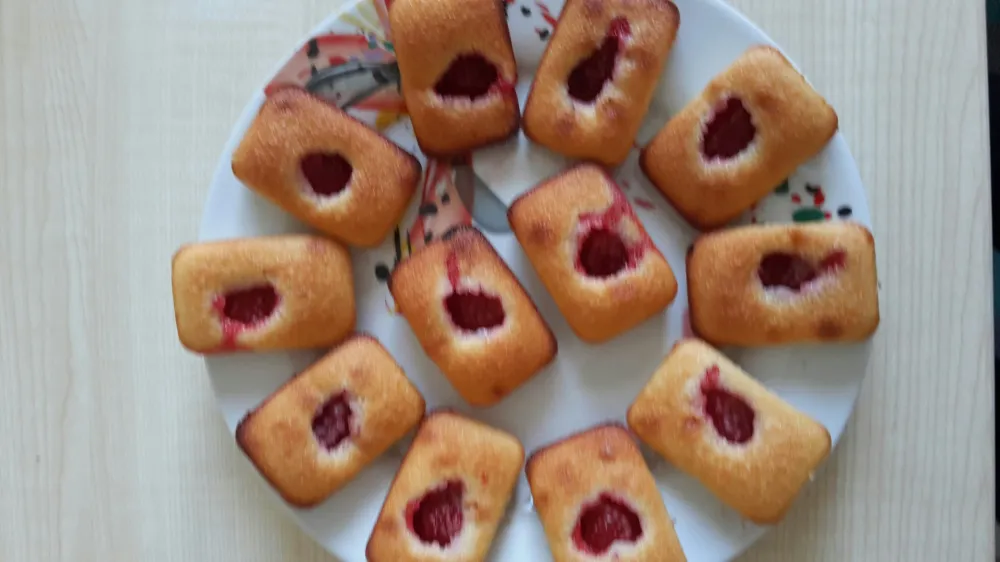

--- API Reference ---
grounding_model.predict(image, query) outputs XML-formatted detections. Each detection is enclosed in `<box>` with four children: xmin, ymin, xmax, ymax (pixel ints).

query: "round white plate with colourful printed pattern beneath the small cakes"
<box><xmin>200</xmin><ymin>0</ymin><xmax>870</xmax><ymax>562</ymax></box>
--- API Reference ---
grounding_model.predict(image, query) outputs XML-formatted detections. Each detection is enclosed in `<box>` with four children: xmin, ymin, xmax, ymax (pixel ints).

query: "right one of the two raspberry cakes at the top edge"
<box><xmin>524</xmin><ymin>0</ymin><xmax>680</xmax><ymax>166</ymax></box>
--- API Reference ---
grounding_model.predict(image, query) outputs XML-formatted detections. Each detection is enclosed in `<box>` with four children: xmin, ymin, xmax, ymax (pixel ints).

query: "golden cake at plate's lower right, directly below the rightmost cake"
<box><xmin>628</xmin><ymin>339</ymin><xmax>830</xmax><ymax>524</ymax></box>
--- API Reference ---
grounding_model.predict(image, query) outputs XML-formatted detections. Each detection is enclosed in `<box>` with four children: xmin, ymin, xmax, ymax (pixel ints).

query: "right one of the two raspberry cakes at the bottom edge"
<box><xmin>526</xmin><ymin>425</ymin><xmax>686</xmax><ymax>562</ymax></box>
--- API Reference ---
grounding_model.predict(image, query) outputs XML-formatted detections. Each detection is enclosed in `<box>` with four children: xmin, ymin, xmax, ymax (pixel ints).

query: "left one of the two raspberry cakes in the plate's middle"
<box><xmin>389</xmin><ymin>228</ymin><xmax>556</xmax><ymax>406</ymax></box>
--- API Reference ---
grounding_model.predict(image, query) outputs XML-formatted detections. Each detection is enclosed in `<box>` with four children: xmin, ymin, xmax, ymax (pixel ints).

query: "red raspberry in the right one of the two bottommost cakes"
<box><xmin>573</xmin><ymin>494</ymin><xmax>642</xmax><ymax>555</ymax></box>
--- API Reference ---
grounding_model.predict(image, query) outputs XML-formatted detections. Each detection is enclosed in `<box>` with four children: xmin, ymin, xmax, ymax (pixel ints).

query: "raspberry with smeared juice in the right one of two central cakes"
<box><xmin>576</xmin><ymin>184</ymin><xmax>651</xmax><ymax>279</ymax></box>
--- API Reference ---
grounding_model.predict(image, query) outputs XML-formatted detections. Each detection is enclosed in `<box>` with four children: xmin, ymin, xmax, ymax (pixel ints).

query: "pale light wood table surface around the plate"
<box><xmin>0</xmin><ymin>0</ymin><xmax>994</xmax><ymax>562</ymax></box>
